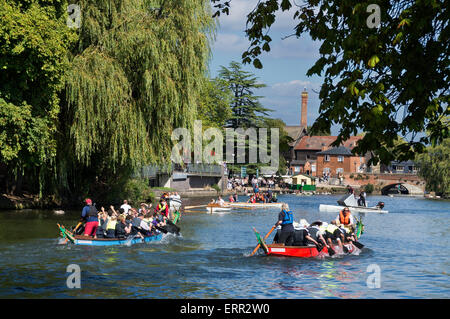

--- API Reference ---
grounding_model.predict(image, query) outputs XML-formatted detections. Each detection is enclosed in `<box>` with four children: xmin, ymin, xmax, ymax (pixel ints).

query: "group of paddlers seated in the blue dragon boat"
<box><xmin>73</xmin><ymin>193</ymin><xmax>181</xmax><ymax>238</ymax></box>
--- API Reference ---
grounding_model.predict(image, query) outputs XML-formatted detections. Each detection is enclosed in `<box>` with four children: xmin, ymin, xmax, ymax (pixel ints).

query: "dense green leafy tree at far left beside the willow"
<box><xmin>0</xmin><ymin>0</ymin><xmax>77</xmax><ymax>193</ymax></box>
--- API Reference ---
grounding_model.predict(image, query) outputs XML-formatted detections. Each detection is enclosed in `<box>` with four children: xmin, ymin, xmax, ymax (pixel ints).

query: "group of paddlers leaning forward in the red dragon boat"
<box><xmin>274</xmin><ymin>204</ymin><xmax>363</xmax><ymax>255</ymax></box>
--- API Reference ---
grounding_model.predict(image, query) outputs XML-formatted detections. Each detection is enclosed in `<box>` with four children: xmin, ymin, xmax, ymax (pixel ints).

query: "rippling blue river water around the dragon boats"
<box><xmin>0</xmin><ymin>195</ymin><xmax>450</xmax><ymax>299</ymax></box>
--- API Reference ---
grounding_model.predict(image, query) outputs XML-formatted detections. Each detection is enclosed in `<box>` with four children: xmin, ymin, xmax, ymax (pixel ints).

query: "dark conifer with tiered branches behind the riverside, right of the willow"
<box><xmin>219</xmin><ymin>61</ymin><xmax>271</xmax><ymax>128</ymax></box>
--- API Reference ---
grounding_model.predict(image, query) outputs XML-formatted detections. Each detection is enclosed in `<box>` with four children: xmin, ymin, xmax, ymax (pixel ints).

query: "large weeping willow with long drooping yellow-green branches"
<box><xmin>59</xmin><ymin>0</ymin><xmax>215</xmax><ymax>200</ymax></box>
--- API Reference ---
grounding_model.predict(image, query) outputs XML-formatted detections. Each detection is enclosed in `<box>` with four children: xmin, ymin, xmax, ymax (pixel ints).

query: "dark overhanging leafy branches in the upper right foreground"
<box><xmin>212</xmin><ymin>0</ymin><xmax>450</xmax><ymax>164</ymax></box>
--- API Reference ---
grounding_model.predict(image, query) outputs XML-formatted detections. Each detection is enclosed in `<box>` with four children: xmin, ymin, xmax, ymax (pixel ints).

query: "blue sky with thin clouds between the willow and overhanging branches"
<box><xmin>210</xmin><ymin>0</ymin><xmax>326</xmax><ymax>133</ymax></box>
